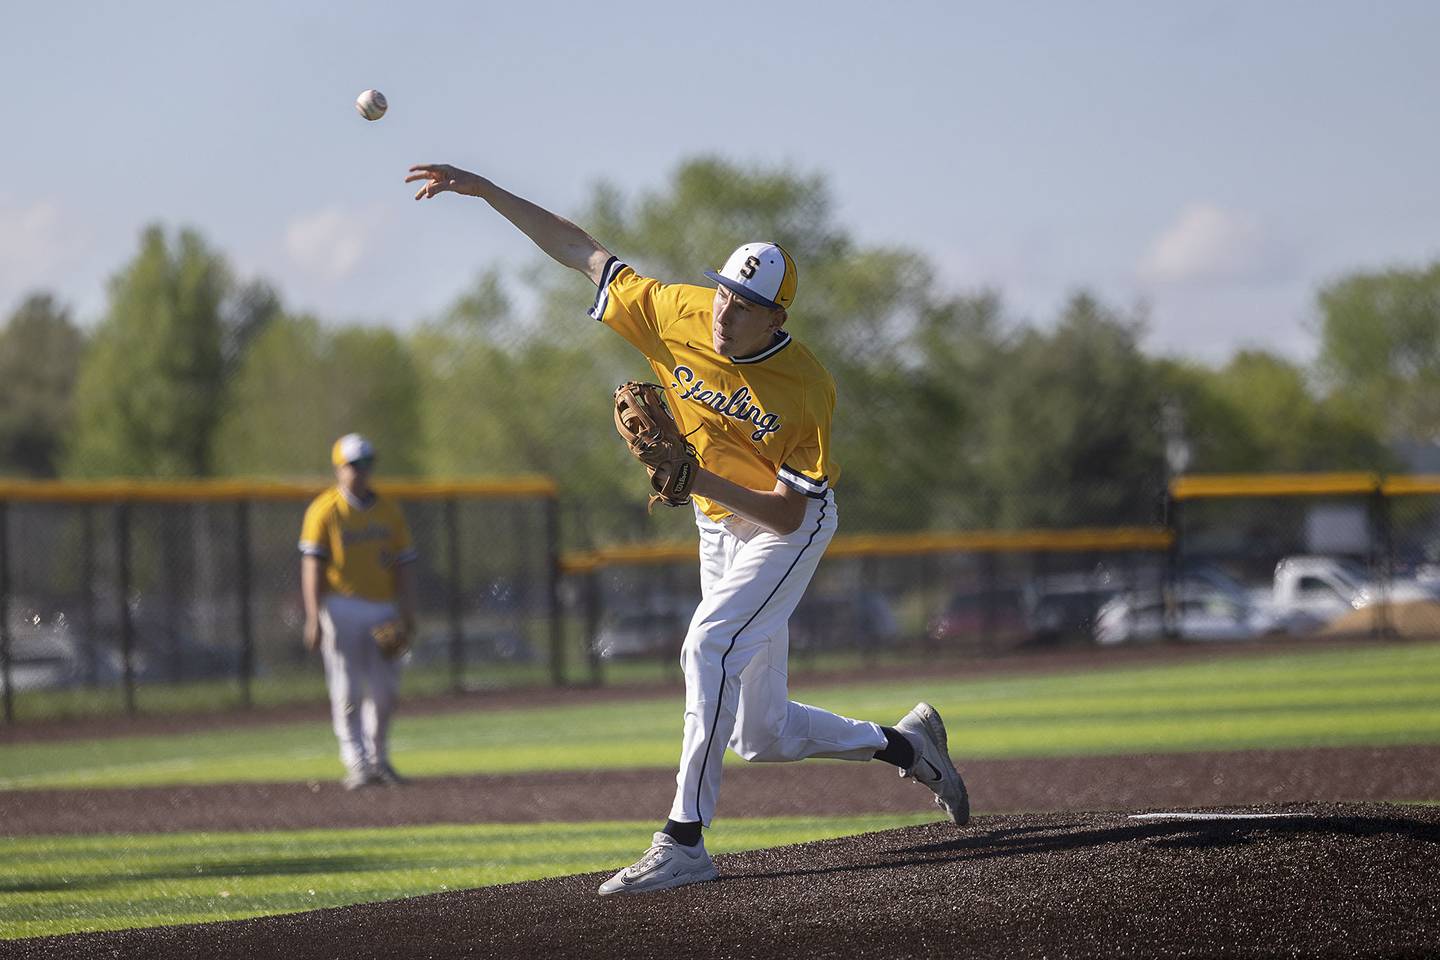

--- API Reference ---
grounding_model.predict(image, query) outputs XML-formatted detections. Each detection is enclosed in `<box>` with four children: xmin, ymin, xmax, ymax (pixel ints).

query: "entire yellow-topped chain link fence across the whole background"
<box><xmin>0</xmin><ymin>474</ymin><xmax>1440</xmax><ymax>723</ymax></box>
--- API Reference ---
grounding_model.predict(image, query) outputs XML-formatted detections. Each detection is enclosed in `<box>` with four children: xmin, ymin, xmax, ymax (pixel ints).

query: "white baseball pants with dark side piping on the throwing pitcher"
<box><xmin>670</xmin><ymin>491</ymin><xmax>886</xmax><ymax>826</ymax></box>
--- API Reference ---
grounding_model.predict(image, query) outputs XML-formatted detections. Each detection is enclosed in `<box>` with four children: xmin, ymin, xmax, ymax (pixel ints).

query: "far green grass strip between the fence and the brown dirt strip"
<box><xmin>0</xmin><ymin>643</ymin><xmax>1440</xmax><ymax>790</ymax></box>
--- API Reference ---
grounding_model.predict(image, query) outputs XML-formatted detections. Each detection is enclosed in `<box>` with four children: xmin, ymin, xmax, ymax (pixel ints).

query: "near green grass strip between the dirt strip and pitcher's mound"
<box><xmin>0</xmin><ymin>813</ymin><xmax>933</xmax><ymax>937</ymax></box>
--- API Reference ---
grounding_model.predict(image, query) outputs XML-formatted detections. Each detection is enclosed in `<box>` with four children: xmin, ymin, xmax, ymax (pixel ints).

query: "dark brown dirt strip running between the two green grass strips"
<box><xmin>8</xmin><ymin>747</ymin><xmax>1440</xmax><ymax>836</ymax></box>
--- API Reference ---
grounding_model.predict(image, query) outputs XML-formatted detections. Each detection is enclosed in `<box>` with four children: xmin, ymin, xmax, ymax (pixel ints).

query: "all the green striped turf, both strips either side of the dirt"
<box><xmin>8</xmin><ymin>643</ymin><xmax>1440</xmax><ymax>937</ymax></box>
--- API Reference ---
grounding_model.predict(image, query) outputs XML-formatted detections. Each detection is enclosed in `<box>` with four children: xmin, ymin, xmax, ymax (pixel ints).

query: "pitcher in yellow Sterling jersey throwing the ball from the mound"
<box><xmin>406</xmin><ymin>164</ymin><xmax>969</xmax><ymax>895</ymax></box>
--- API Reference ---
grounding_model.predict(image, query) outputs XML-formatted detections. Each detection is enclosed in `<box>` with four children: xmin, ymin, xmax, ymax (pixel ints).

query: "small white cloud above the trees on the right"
<box><xmin>1139</xmin><ymin>203</ymin><xmax>1276</xmax><ymax>284</ymax></box>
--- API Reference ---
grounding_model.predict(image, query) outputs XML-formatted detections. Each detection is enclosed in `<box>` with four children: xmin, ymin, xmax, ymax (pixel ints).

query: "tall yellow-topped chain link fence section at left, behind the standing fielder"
<box><xmin>0</xmin><ymin>481</ymin><xmax>566</xmax><ymax>721</ymax></box>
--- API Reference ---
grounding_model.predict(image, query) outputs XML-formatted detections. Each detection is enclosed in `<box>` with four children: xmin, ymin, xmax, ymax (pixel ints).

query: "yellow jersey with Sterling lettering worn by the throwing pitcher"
<box><xmin>590</xmin><ymin>258</ymin><xmax>840</xmax><ymax>520</ymax></box>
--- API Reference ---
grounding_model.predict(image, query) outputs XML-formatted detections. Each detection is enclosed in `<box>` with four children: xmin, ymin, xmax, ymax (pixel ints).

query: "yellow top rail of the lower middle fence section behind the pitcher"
<box><xmin>560</xmin><ymin>527</ymin><xmax>1174</xmax><ymax>573</ymax></box>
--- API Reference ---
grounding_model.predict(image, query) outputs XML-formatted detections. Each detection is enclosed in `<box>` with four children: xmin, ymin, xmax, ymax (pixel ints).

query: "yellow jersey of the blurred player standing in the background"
<box><xmin>300</xmin><ymin>486</ymin><xmax>418</xmax><ymax>602</ymax></box>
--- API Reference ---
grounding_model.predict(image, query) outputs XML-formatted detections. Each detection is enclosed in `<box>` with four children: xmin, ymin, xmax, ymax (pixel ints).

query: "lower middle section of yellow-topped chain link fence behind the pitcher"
<box><xmin>563</xmin><ymin>528</ymin><xmax>1171</xmax><ymax>684</ymax></box>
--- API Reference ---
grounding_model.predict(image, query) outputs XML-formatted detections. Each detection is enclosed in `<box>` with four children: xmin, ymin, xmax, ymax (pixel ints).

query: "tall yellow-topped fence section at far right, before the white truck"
<box><xmin>1168</xmin><ymin>474</ymin><xmax>1440</xmax><ymax>639</ymax></box>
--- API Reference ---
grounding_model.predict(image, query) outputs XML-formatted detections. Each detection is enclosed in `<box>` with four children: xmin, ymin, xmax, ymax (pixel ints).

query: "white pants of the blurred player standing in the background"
<box><xmin>320</xmin><ymin>593</ymin><xmax>400</xmax><ymax>771</ymax></box>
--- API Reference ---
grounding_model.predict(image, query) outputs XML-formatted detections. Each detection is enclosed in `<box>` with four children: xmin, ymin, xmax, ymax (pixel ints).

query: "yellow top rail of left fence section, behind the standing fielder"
<box><xmin>0</xmin><ymin>476</ymin><xmax>557</xmax><ymax>504</ymax></box>
